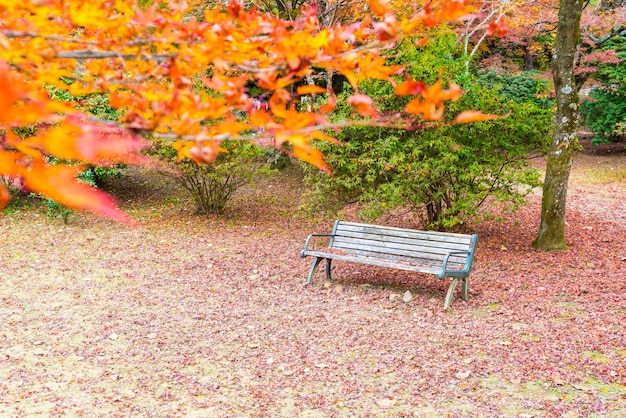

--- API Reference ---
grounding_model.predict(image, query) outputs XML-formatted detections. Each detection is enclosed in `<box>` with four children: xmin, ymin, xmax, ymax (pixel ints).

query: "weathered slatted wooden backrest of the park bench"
<box><xmin>330</xmin><ymin>220</ymin><xmax>477</xmax><ymax>269</ymax></box>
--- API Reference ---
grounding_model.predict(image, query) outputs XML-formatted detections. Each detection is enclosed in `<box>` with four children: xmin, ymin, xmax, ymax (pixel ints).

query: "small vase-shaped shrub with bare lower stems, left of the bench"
<box><xmin>154</xmin><ymin>141</ymin><xmax>272</xmax><ymax>214</ymax></box>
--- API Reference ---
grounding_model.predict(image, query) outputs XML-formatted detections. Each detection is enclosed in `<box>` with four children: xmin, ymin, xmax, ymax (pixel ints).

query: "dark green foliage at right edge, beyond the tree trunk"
<box><xmin>582</xmin><ymin>37</ymin><xmax>626</xmax><ymax>144</ymax></box>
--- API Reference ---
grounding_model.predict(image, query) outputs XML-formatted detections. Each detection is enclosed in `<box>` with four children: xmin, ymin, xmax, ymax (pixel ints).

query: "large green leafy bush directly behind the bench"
<box><xmin>307</xmin><ymin>40</ymin><xmax>551</xmax><ymax>229</ymax></box>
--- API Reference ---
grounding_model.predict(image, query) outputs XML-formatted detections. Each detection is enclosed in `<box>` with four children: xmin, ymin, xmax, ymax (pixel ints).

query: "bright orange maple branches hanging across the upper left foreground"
<box><xmin>0</xmin><ymin>0</ymin><xmax>498</xmax><ymax>221</ymax></box>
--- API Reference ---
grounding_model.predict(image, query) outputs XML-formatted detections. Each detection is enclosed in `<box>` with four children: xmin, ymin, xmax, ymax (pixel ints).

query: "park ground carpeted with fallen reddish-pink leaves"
<box><xmin>0</xmin><ymin>143</ymin><xmax>626</xmax><ymax>418</ymax></box>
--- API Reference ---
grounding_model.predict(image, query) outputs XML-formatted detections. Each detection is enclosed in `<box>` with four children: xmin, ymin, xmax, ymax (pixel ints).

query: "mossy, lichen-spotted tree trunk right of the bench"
<box><xmin>533</xmin><ymin>0</ymin><xmax>583</xmax><ymax>250</ymax></box>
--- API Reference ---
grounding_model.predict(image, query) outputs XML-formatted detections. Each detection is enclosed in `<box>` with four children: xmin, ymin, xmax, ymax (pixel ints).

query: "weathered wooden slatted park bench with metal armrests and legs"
<box><xmin>300</xmin><ymin>220</ymin><xmax>478</xmax><ymax>309</ymax></box>
